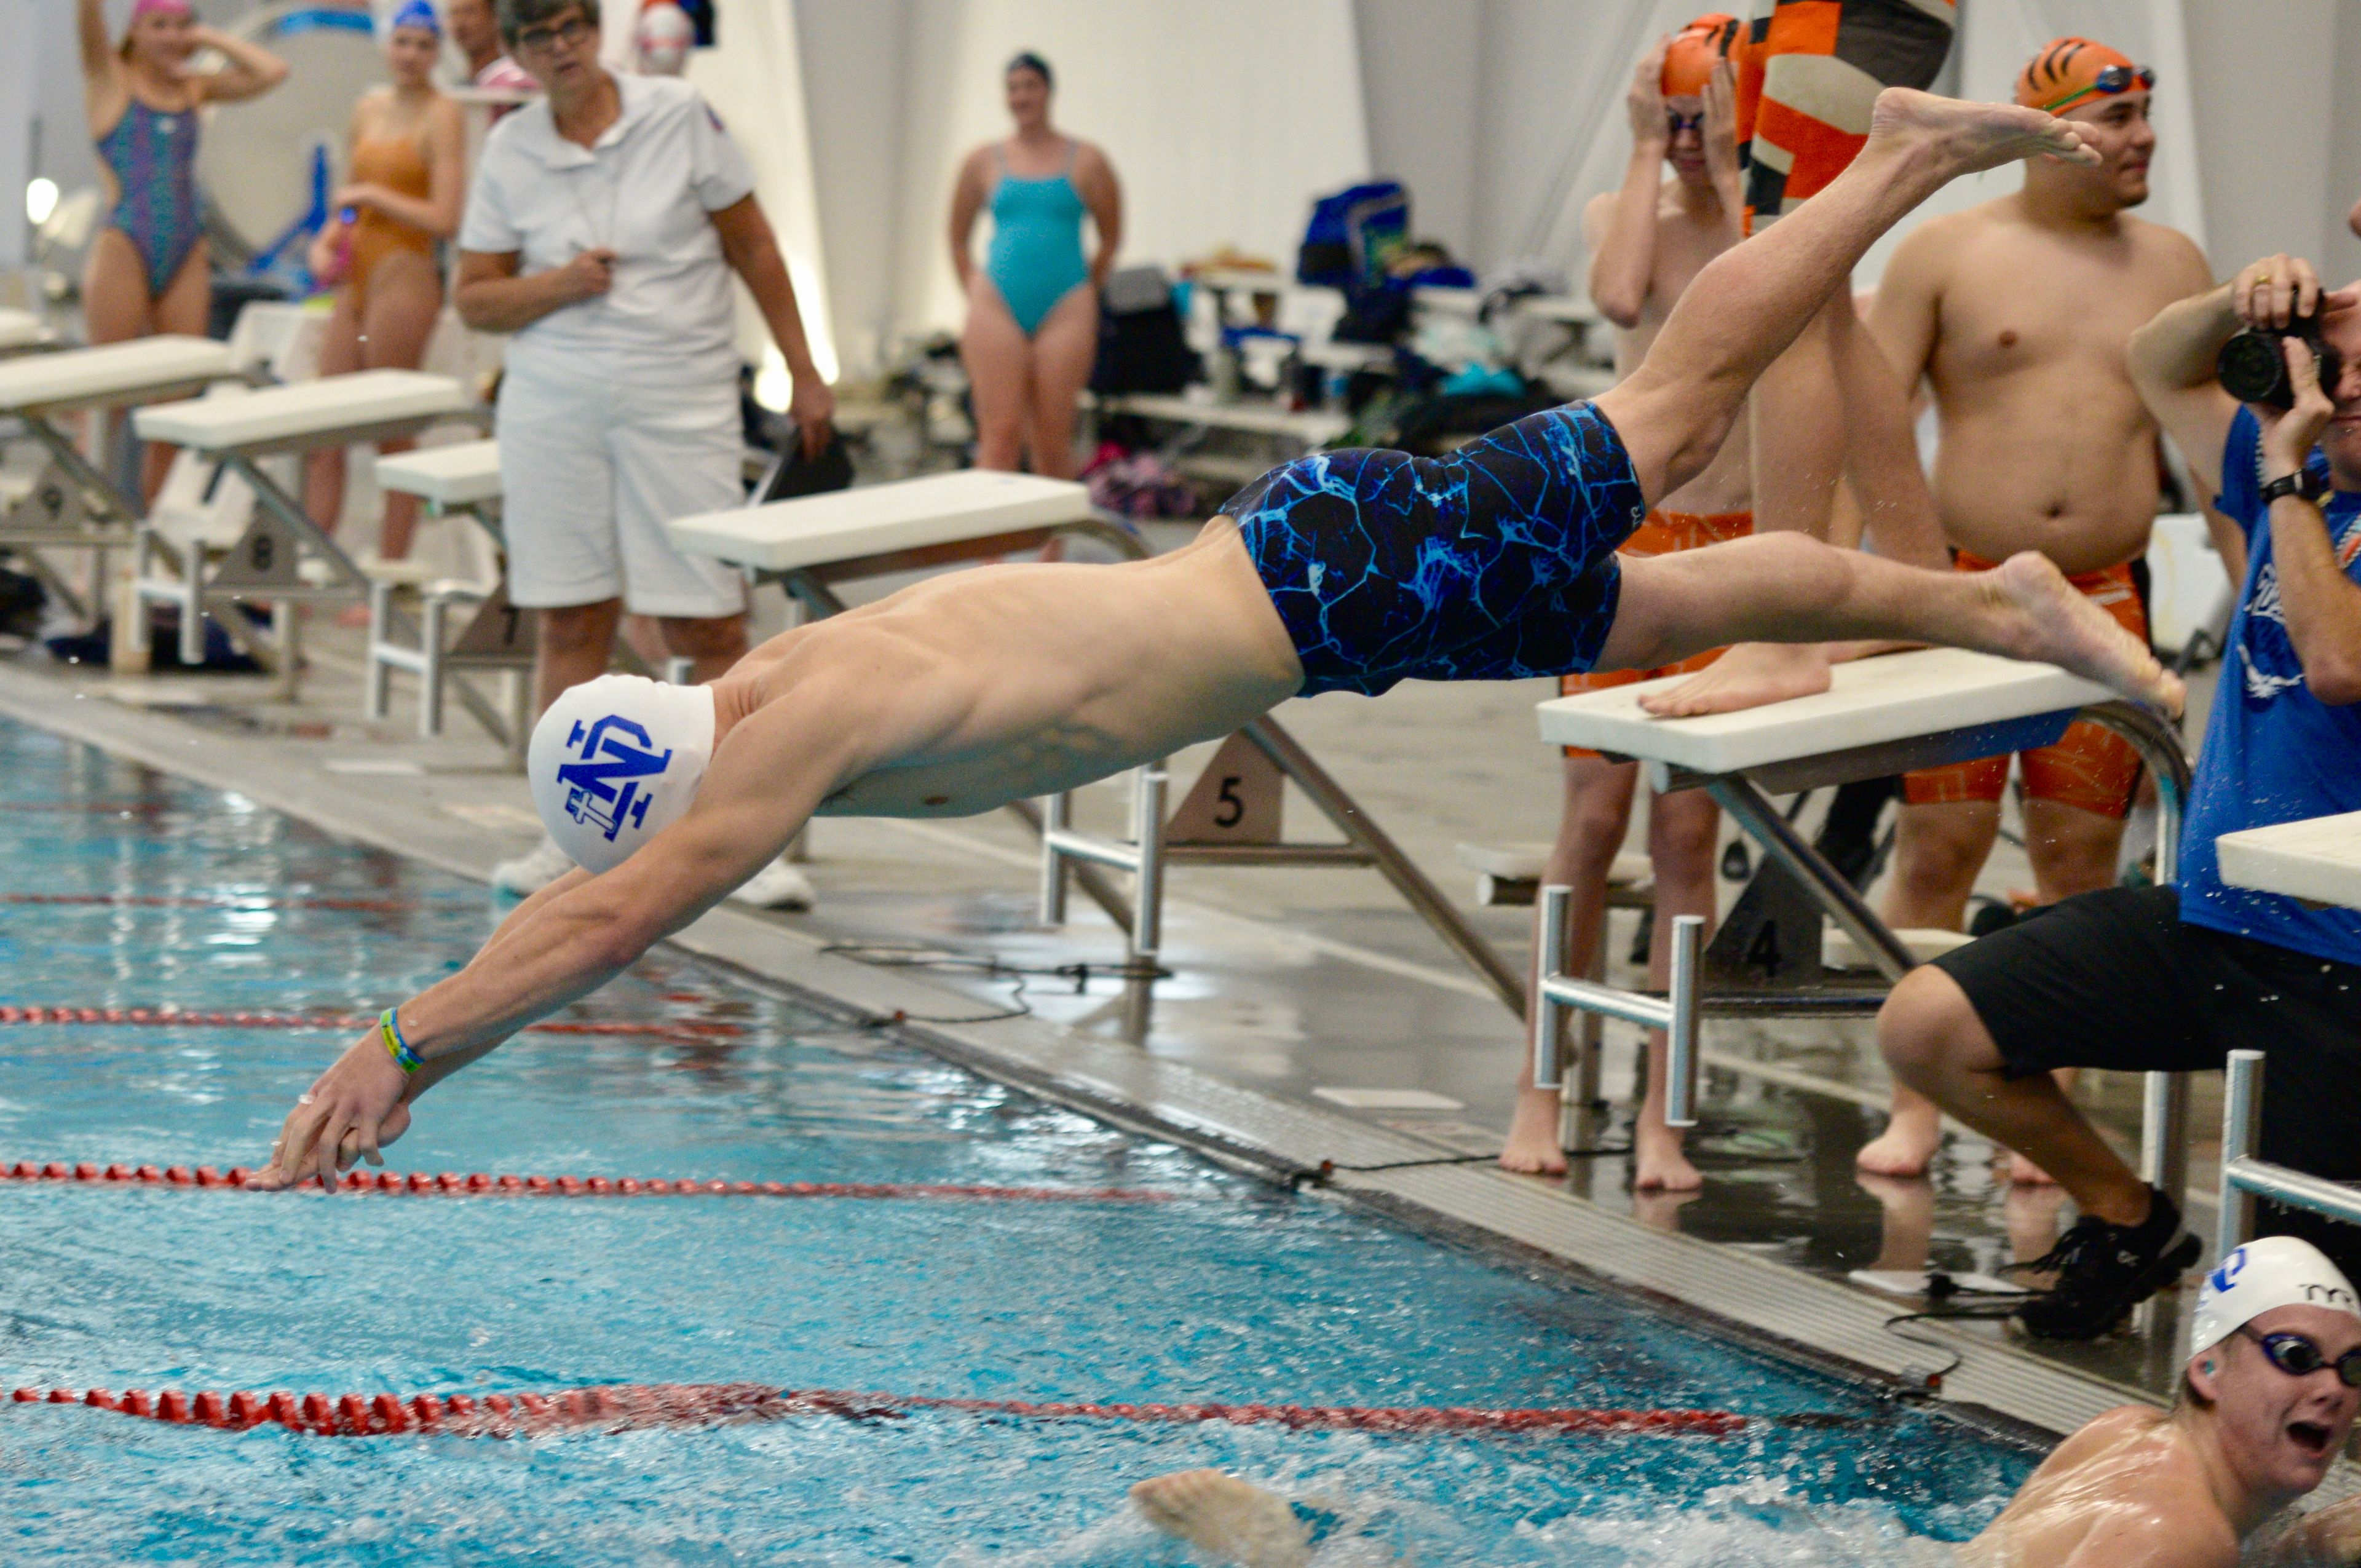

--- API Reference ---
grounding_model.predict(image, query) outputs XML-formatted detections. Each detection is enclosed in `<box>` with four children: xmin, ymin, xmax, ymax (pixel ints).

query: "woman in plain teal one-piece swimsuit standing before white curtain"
<box><xmin>952</xmin><ymin>54</ymin><xmax>1124</xmax><ymax>480</ymax></box>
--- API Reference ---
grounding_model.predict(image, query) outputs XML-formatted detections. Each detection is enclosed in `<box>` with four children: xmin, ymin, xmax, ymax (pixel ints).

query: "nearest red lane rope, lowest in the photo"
<box><xmin>12</xmin><ymin>1384</ymin><xmax>1756</xmax><ymax>1438</ymax></box>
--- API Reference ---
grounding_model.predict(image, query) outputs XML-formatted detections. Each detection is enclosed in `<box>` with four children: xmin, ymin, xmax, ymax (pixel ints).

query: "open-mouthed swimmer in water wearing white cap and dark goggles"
<box><xmin>1131</xmin><ymin>1235</ymin><xmax>2361</xmax><ymax>1568</ymax></box>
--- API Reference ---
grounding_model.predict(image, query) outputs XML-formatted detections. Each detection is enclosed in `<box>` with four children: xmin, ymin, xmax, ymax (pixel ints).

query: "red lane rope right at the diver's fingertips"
<box><xmin>0</xmin><ymin>1160</ymin><xmax>1180</xmax><ymax>1205</ymax></box>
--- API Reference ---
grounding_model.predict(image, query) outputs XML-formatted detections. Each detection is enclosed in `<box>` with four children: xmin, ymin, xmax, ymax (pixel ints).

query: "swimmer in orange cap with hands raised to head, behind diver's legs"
<box><xmin>1499</xmin><ymin>17</ymin><xmax>1754</xmax><ymax>1192</ymax></box>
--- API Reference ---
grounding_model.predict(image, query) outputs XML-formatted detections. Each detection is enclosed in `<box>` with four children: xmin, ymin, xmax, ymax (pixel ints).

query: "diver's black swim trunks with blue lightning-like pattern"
<box><xmin>1220</xmin><ymin>404</ymin><xmax>1648</xmax><ymax>697</ymax></box>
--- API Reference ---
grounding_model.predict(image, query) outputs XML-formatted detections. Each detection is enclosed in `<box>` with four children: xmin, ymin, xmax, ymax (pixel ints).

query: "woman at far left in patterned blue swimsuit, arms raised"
<box><xmin>81</xmin><ymin>0</ymin><xmax>288</xmax><ymax>496</ymax></box>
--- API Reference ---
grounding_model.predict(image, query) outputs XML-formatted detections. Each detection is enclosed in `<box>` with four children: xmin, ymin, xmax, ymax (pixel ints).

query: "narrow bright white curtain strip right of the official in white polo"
<box><xmin>684</xmin><ymin>0</ymin><xmax>838</xmax><ymax>389</ymax></box>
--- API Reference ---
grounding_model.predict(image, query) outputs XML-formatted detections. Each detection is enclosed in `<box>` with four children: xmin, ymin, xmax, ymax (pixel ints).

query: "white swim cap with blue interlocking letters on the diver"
<box><xmin>524</xmin><ymin>675</ymin><xmax>713</xmax><ymax>871</ymax></box>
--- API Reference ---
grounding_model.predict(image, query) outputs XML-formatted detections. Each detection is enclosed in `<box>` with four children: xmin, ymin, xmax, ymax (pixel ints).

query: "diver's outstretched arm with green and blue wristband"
<box><xmin>250</xmin><ymin>659</ymin><xmax>942</xmax><ymax>1190</ymax></box>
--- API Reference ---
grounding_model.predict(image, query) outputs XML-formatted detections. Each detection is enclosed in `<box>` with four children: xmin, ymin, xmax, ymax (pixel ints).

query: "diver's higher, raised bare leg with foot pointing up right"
<box><xmin>1599</xmin><ymin>87</ymin><xmax>2094</xmax><ymax>507</ymax></box>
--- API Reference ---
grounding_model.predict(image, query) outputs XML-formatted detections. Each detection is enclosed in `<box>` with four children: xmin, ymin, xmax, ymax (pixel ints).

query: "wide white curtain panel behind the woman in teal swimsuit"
<box><xmin>887</xmin><ymin>0</ymin><xmax>1369</xmax><ymax>328</ymax></box>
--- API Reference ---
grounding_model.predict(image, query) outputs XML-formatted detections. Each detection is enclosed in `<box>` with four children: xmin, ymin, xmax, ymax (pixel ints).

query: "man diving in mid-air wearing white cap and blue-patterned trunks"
<box><xmin>244</xmin><ymin>90</ymin><xmax>2181</xmax><ymax>1190</ymax></box>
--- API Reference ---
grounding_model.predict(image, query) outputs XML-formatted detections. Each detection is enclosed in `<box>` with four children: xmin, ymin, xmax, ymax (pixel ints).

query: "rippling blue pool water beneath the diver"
<box><xmin>0</xmin><ymin>727</ymin><xmax>2033</xmax><ymax>1563</ymax></box>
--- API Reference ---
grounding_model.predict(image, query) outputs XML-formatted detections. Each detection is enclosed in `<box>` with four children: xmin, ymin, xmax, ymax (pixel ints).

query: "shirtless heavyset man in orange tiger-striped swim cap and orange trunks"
<box><xmin>1861</xmin><ymin>38</ymin><xmax>2212</xmax><ymax>1181</ymax></box>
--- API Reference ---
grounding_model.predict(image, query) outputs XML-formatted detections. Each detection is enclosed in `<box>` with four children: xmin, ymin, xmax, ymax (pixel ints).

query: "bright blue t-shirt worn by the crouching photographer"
<box><xmin>2181</xmin><ymin>408</ymin><xmax>2361</xmax><ymax>964</ymax></box>
